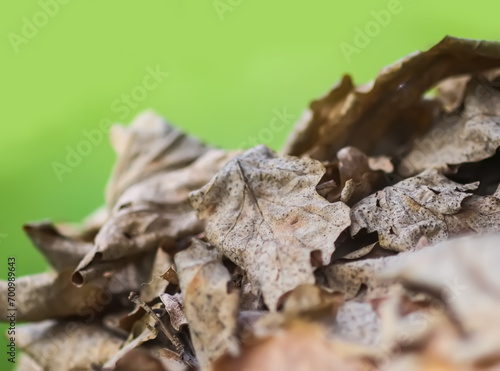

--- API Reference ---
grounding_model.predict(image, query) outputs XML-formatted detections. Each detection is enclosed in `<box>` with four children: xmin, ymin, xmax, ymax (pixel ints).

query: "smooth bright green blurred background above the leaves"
<box><xmin>0</xmin><ymin>0</ymin><xmax>500</xmax><ymax>370</ymax></box>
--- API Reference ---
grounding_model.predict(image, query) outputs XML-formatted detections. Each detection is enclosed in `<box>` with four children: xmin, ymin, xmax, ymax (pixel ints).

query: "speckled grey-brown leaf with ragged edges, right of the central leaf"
<box><xmin>351</xmin><ymin>169</ymin><xmax>478</xmax><ymax>251</ymax></box>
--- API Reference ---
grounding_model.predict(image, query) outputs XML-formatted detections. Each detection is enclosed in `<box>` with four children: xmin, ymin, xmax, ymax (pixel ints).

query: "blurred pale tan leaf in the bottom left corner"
<box><xmin>17</xmin><ymin>321</ymin><xmax>123</xmax><ymax>371</ymax></box>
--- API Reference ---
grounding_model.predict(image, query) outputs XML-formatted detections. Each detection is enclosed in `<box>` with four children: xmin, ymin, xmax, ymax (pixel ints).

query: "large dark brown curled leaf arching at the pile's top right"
<box><xmin>283</xmin><ymin>36</ymin><xmax>500</xmax><ymax>161</ymax></box>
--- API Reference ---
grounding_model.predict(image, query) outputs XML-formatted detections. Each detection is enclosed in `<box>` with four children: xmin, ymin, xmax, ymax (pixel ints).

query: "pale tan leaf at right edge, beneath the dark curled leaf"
<box><xmin>399</xmin><ymin>76</ymin><xmax>500</xmax><ymax>176</ymax></box>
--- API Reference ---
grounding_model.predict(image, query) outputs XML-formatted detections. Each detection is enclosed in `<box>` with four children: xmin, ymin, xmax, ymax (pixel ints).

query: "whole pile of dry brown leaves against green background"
<box><xmin>0</xmin><ymin>37</ymin><xmax>500</xmax><ymax>371</ymax></box>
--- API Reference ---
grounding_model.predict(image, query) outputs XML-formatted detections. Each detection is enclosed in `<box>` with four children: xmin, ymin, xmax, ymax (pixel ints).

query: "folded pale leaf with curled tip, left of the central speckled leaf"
<box><xmin>76</xmin><ymin>150</ymin><xmax>236</xmax><ymax>280</ymax></box>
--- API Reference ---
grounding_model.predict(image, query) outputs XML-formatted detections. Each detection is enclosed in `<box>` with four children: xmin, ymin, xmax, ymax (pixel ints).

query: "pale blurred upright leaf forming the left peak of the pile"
<box><xmin>106</xmin><ymin>112</ymin><xmax>208</xmax><ymax>208</ymax></box>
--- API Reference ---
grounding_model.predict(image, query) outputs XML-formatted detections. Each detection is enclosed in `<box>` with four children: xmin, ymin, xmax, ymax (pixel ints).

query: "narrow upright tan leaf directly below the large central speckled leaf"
<box><xmin>174</xmin><ymin>239</ymin><xmax>239</xmax><ymax>370</ymax></box>
